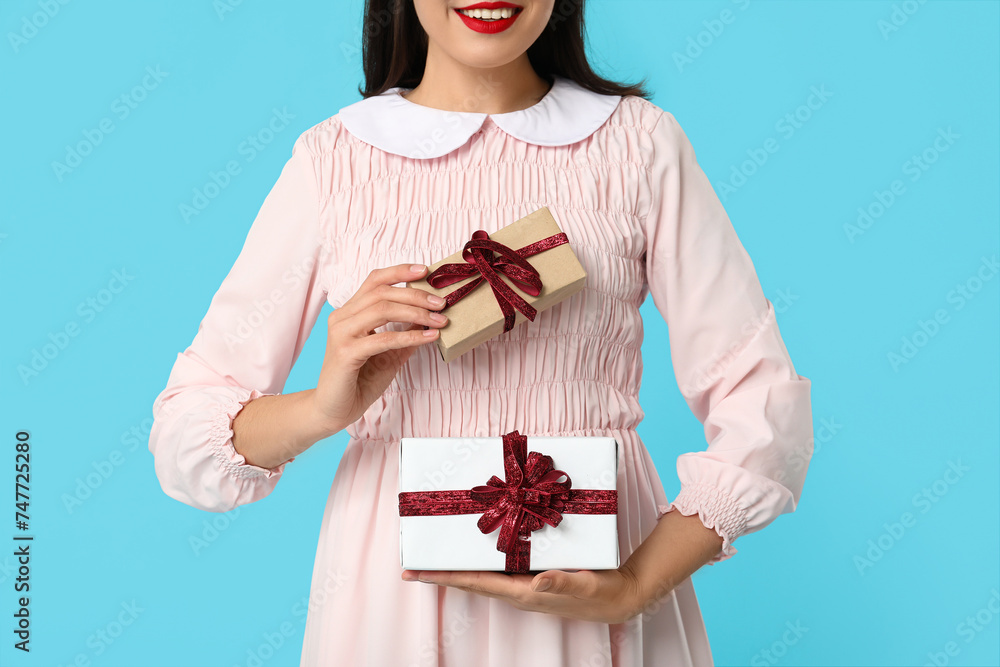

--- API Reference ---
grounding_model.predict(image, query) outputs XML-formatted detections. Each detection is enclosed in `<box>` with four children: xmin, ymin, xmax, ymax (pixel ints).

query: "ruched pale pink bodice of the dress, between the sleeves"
<box><xmin>323</xmin><ymin>117</ymin><xmax>647</xmax><ymax>441</ymax></box>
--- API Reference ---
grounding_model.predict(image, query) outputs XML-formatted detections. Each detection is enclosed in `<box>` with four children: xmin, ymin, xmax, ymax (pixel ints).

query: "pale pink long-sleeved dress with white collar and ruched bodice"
<box><xmin>149</xmin><ymin>77</ymin><xmax>812</xmax><ymax>667</ymax></box>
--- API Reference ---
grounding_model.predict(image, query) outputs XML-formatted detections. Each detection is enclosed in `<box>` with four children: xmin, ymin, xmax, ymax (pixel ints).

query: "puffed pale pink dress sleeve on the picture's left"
<box><xmin>149</xmin><ymin>131</ymin><xmax>326</xmax><ymax>512</ymax></box>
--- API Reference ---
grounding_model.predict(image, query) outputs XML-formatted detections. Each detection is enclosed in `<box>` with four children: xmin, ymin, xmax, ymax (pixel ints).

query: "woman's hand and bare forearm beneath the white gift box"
<box><xmin>402</xmin><ymin>510</ymin><xmax>723</xmax><ymax>623</ymax></box>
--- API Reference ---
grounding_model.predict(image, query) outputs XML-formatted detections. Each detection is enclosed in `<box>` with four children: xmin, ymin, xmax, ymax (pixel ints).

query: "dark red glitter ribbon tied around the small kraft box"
<box><xmin>427</xmin><ymin>229</ymin><xmax>569</xmax><ymax>333</ymax></box>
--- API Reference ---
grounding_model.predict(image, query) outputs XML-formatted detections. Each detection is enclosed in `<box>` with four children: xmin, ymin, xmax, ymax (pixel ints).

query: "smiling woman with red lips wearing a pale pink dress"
<box><xmin>150</xmin><ymin>0</ymin><xmax>812</xmax><ymax>667</ymax></box>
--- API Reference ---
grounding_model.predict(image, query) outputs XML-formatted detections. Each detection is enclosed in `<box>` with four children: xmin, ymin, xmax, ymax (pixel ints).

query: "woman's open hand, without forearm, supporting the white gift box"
<box><xmin>403</xmin><ymin>563</ymin><xmax>642</xmax><ymax>623</ymax></box>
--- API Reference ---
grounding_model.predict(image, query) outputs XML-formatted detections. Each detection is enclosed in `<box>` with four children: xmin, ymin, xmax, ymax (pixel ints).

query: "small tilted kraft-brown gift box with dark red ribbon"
<box><xmin>406</xmin><ymin>207</ymin><xmax>587</xmax><ymax>363</ymax></box>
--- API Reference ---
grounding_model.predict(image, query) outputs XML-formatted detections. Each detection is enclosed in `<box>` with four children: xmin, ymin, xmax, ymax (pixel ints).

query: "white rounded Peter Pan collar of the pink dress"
<box><xmin>338</xmin><ymin>75</ymin><xmax>621</xmax><ymax>159</ymax></box>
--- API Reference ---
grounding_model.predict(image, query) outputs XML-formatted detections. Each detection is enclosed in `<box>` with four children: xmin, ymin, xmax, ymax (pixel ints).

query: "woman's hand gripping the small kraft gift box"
<box><xmin>313</xmin><ymin>264</ymin><xmax>448</xmax><ymax>434</ymax></box>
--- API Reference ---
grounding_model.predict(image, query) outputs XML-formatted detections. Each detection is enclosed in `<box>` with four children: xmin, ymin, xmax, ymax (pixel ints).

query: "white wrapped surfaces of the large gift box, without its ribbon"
<box><xmin>399</xmin><ymin>432</ymin><xmax>619</xmax><ymax>571</ymax></box>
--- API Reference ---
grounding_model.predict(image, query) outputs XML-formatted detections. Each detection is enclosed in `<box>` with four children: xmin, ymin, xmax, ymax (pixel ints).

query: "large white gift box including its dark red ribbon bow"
<box><xmin>399</xmin><ymin>431</ymin><xmax>619</xmax><ymax>573</ymax></box>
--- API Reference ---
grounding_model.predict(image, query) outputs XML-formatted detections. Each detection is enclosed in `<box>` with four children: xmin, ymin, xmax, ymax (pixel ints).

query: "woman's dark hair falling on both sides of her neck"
<box><xmin>358</xmin><ymin>0</ymin><xmax>651</xmax><ymax>99</ymax></box>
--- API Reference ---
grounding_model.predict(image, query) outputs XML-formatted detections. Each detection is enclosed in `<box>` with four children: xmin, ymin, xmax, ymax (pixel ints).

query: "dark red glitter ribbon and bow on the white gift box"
<box><xmin>399</xmin><ymin>431</ymin><xmax>618</xmax><ymax>572</ymax></box>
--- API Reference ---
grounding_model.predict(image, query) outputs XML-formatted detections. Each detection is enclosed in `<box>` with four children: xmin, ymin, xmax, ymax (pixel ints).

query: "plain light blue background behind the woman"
<box><xmin>0</xmin><ymin>0</ymin><xmax>1000</xmax><ymax>667</ymax></box>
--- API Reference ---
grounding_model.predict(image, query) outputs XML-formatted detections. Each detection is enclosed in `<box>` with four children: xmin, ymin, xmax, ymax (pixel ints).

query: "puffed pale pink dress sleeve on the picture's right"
<box><xmin>645</xmin><ymin>111</ymin><xmax>813</xmax><ymax>564</ymax></box>
